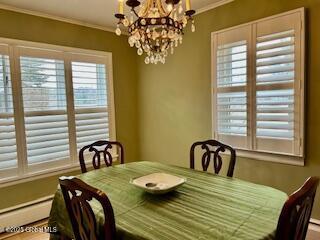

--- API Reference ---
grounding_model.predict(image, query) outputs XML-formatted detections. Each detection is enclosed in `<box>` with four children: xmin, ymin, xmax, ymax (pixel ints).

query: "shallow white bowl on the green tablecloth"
<box><xmin>130</xmin><ymin>173</ymin><xmax>187</xmax><ymax>194</ymax></box>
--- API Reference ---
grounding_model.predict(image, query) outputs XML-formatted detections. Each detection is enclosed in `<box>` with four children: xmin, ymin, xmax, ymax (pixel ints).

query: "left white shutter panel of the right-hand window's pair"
<box><xmin>213</xmin><ymin>27</ymin><xmax>251</xmax><ymax>148</ymax></box>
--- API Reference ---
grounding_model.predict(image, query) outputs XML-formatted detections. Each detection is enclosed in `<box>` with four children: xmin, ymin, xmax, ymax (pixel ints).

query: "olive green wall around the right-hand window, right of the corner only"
<box><xmin>138</xmin><ymin>0</ymin><xmax>320</xmax><ymax>219</ymax></box>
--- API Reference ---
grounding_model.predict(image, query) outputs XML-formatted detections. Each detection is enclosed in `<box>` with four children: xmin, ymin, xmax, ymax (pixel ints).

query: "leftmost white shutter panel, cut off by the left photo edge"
<box><xmin>0</xmin><ymin>45</ymin><xmax>18</xmax><ymax>178</ymax></box>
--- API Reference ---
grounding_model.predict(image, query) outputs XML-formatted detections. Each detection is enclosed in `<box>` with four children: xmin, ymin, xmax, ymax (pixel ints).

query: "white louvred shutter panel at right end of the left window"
<box><xmin>72</xmin><ymin>61</ymin><xmax>109</xmax><ymax>150</ymax></box>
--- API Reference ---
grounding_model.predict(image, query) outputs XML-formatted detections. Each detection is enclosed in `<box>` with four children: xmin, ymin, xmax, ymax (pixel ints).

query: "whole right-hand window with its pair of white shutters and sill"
<box><xmin>212</xmin><ymin>9</ymin><xmax>304</xmax><ymax>165</ymax></box>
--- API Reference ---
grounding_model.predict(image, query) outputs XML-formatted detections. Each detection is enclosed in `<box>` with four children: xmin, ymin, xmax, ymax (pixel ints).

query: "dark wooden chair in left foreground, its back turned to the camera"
<box><xmin>59</xmin><ymin>177</ymin><xmax>116</xmax><ymax>240</ymax></box>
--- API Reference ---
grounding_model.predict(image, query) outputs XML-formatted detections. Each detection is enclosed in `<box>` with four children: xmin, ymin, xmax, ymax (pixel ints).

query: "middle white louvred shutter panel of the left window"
<box><xmin>19</xmin><ymin>47</ymin><xmax>70</xmax><ymax>170</ymax></box>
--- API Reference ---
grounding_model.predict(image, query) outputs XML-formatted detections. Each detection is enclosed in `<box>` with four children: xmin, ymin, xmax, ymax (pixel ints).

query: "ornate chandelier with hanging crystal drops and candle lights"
<box><xmin>115</xmin><ymin>0</ymin><xmax>195</xmax><ymax>64</ymax></box>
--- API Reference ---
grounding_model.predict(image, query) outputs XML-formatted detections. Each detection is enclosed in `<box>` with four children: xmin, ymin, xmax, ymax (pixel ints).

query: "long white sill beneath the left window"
<box><xmin>0</xmin><ymin>155</ymin><xmax>118</xmax><ymax>188</ymax></box>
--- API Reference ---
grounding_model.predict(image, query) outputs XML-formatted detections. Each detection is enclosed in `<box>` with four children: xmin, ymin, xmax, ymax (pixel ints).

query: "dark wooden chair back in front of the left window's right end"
<box><xmin>79</xmin><ymin>140</ymin><xmax>124</xmax><ymax>173</ymax></box>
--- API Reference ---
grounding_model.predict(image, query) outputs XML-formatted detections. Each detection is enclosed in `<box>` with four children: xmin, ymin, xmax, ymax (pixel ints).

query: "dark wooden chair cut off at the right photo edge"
<box><xmin>276</xmin><ymin>177</ymin><xmax>319</xmax><ymax>240</ymax></box>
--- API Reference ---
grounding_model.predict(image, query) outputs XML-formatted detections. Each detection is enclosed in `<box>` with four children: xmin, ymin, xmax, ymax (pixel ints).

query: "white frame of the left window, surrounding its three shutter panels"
<box><xmin>0</xmin><ymin>38</ymin><xmax>117</xmax><ymax>188</ymax></box>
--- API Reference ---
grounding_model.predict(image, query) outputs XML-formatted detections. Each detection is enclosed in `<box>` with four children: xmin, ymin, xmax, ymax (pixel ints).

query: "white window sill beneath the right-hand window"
<box><xmin>236</xmin><ymin>149</ymin><xmax>305</xmax><ymax>167</ymax></box>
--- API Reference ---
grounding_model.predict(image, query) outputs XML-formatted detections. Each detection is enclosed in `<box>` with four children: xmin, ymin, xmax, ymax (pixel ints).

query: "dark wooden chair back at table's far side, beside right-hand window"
<box><xmin>190</xmin><ymin>140</ymin><xmax>236</xmax><ymax>177</ymax></box>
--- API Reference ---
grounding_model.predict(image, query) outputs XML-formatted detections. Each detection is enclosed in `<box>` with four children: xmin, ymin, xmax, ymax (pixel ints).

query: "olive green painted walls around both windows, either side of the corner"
<box><xmin>0</xmin><ymin>0</ymin><xmax>320</xmax><ymax>219</ymax></box>
